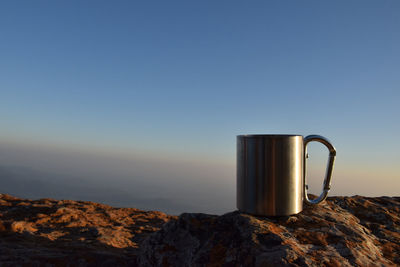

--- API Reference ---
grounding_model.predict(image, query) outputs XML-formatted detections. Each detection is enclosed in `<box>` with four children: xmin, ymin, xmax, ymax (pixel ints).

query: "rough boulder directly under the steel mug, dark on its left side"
<box><xmin>138</xmin><ymin>196</ymin><xmax>400</xmax><ymax>266</ymax></box>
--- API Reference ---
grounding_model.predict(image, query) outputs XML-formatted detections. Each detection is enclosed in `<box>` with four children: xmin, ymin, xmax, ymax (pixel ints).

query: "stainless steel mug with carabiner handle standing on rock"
<box><xmin>236</xmin><ymin>135</ymin><xmax>336</xmax><ymax>216</ymax></box>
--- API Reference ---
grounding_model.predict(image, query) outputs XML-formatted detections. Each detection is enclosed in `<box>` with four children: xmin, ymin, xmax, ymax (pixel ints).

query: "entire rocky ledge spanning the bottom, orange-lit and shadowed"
<box><xmin>0</xmin><ymin>194</ymin><xmax>400</xmax><ymax>266</ymax></box>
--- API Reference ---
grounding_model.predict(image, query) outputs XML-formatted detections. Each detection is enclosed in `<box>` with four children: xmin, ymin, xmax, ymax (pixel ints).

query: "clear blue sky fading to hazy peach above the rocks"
<box><xmin>0</xmin><ymin>0</ymin><xmax>400</xmax><ymax>213</ymax></box>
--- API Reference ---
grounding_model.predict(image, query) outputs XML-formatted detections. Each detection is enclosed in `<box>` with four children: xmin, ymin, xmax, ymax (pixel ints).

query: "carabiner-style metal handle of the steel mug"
<box><xmin>303</xmin><ymin>135</ymin><xmax>336</xmax><ymax>204</ymax></box>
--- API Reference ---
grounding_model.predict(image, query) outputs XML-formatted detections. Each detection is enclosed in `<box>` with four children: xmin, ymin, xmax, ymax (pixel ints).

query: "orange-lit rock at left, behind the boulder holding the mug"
<box><xmin>0</xmin><ymin>194</ymin><xmax>176</xmax><ymax>266</ymax></box>
